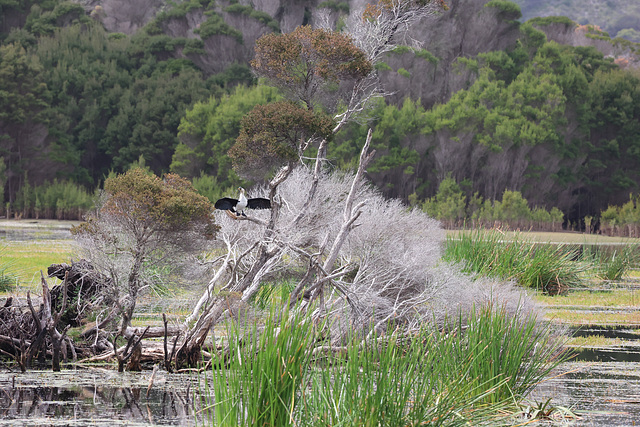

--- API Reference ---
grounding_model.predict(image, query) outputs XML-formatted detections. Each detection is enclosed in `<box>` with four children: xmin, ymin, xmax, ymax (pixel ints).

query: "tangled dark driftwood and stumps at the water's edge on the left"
<box><xmin>0</xmin><ymin>260</ymin><xmax>190</xmax><ymax>372</ymax></box>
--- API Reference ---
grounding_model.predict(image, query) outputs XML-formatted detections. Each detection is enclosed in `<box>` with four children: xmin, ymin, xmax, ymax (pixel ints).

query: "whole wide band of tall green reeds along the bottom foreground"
<box><xmin>202</xmin><ymin>307</ymin><xmax>563</xmax><ymax>426</ymax></box>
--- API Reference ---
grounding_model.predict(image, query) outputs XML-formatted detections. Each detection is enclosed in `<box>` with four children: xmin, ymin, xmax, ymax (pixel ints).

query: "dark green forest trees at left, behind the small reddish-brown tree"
<box><xmin>0</xmin><ymin>0</ymin><xmax>245</xmax><ymax>218</ymax></box>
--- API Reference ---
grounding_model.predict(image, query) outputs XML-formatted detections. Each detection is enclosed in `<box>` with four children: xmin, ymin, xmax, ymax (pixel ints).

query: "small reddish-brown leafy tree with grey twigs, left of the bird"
<box><xmin>73</xmin><ymin>169</ymin><xmax>215</xmax><ymax>336</ymax></box>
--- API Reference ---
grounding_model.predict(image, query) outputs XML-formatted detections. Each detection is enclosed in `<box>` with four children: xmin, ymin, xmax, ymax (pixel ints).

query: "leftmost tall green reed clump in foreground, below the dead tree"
<box><xmin>209</xmin><ymin>311</ymin><xmax>315</xmax><ymax>426</ymax></box>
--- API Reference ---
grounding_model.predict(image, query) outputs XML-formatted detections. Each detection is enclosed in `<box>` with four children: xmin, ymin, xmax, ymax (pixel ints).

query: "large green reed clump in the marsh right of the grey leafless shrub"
<box><xmin>443</xmin><ymin>229</ymin><xmax>586</xmax><ymax>294</ymax></box>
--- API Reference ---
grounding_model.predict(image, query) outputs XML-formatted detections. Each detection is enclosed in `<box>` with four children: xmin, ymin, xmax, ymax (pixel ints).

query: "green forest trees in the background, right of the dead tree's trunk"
<box><xmin>330</xmin><ymin>29</ymin><xmax>640</xmax><ymax>221</ymax></box>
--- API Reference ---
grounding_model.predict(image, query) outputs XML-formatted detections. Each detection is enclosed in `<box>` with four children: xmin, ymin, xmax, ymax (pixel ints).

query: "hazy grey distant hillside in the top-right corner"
<box><xmin>513</xmin><ymin>0</ymin><xmax>640</xmax><ymax>42</ymax></box>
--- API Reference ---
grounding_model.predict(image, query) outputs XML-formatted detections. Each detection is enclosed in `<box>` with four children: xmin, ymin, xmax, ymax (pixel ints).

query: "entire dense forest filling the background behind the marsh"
<box><xmin>0</xmin><ymin>0</ymin><xmax>640</xmax><ymax>236</ymax></box>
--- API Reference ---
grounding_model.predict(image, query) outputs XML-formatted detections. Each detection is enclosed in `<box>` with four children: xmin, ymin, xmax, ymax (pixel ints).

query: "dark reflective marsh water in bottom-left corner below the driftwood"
<box><xmin>0</xmin><ymin>371</ymin><xmax>198</xmax><ymax>426</ymax></box>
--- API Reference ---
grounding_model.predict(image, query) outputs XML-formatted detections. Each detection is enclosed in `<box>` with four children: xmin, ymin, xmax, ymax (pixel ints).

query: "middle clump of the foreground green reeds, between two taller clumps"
<box><xmin>300</xmin><ymin>328</ymin><xmax>503</xmax><ymax>426</ymax></box>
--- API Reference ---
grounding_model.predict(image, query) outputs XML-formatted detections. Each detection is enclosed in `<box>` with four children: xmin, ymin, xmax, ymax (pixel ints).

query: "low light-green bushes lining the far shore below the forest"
<box><xmin>0</xmin><ymin>175</ymin><xmax>640</xmax><ymax>238</ymax></box>
